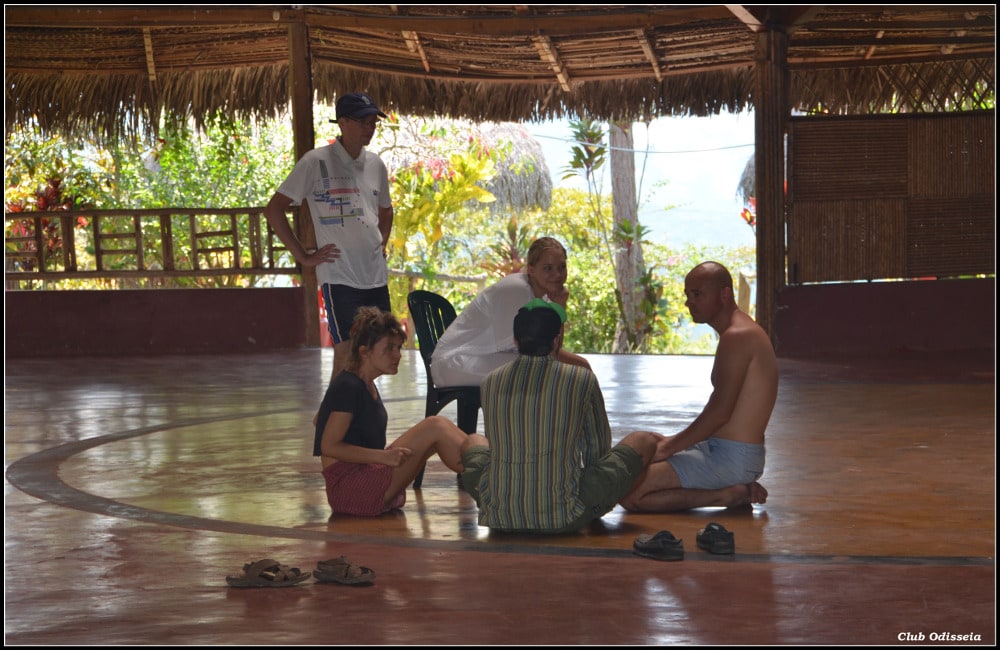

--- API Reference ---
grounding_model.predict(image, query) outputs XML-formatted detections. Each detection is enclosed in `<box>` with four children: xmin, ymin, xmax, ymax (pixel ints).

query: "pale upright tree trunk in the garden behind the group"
<box><xmin>610</xmin><ymin>122</ymin><xmax>646</xmax><ymax>354</ymax></box>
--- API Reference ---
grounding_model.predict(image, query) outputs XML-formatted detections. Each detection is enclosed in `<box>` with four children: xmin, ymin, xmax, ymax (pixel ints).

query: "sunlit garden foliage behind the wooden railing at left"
<box><xmin>4</xmin><ymin>116</ymin><xmax>294</xmax><ymax>288</ymax></box>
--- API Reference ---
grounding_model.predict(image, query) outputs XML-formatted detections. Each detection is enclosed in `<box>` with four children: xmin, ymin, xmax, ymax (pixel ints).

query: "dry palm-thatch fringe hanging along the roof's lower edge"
<box><xmin>5</xmin><ymin>58</ymin><xmax>996</xmax><ymax>147</ymax></box>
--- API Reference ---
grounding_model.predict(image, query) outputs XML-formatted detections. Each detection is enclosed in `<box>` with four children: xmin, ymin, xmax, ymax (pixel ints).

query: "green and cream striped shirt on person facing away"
<box><xmin>479</xmin><ymin>355</ymin><xmax>611</xmax><ymax>530</ymax></box>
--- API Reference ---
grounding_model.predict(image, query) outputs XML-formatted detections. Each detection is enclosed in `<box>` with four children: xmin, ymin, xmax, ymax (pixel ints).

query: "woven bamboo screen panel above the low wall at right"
<box><xmin>787</xmin><ymin>112</ymin><xmax>996</xmax><ymax>284</ymax></box>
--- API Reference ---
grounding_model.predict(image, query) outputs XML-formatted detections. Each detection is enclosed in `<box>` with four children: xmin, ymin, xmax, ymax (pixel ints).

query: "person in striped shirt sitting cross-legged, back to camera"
<box><xmin>460</xmin><ymin>298</ymin><xmax>662</xmax><ymax>534</ymax></box>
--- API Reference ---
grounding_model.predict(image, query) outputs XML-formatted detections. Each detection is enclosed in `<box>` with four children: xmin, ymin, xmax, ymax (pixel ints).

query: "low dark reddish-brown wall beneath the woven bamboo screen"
<box><xmin>775</xmin><ymin>278</ymin><xmax>996</xmax><ymax>358</ymax></box>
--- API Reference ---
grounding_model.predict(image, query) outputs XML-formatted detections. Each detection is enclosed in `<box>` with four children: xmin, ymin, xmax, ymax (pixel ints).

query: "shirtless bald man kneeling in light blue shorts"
<box><xmin>621</xmin><ymin>262</ymin><xmax>778</xmax><ymax>512</ymax></box>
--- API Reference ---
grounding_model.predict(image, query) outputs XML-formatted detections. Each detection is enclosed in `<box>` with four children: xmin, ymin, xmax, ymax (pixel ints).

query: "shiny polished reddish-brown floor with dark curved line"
<box><xmin>4</xmin><ymin>349</ymin><xmax>996</xmax><ymax>646</ymax></box>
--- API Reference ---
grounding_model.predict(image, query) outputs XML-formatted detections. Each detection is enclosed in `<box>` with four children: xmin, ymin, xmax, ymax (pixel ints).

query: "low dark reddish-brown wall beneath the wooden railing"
<box><xmin>4</xmin><ymin>287</ymin><xmax>305</xmax><ymax>358</ymax></box>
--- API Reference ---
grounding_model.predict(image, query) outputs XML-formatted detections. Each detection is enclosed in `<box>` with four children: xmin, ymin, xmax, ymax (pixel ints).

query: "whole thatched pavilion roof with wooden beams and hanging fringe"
<box><xmin>4</xmin><ymin>5</ymin><xmax>996</xmax><ymax>143</ymax></box>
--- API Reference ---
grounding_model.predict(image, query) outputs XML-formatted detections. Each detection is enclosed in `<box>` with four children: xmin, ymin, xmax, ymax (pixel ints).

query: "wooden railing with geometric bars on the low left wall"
<box><xmin>4</xmin><ymin>207</ymin><xmax>300</xmax><ymax>288</ymax></box>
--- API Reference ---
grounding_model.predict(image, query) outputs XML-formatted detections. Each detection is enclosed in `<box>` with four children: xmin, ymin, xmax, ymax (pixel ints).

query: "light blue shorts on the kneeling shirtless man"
<box><xmin>667</xmin><ymin>438</ymin><xmax>764</xmax><ymax>490</ymax></box>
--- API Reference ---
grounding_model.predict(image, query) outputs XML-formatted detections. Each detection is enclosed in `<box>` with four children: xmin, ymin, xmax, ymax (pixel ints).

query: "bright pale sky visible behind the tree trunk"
<box><xmin>525</xmin><ymin>113</ymin><xmax>754</xmax><ymax>246</ymax></box>
